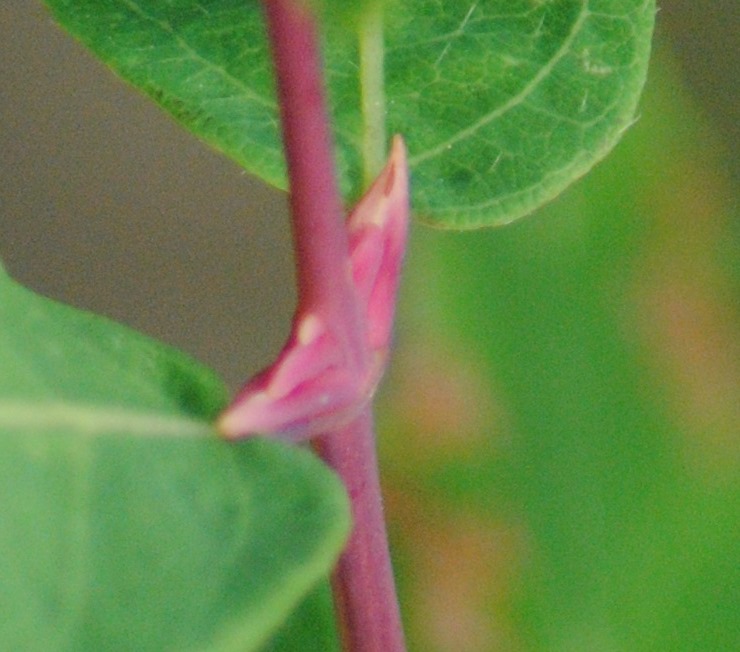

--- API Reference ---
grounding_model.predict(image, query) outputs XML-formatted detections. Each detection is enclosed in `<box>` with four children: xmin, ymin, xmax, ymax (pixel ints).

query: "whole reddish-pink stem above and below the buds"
<box><xmin>264</xmin><ymin>0</ymin><xmax>405</xmax><ymax>652</ymax></box>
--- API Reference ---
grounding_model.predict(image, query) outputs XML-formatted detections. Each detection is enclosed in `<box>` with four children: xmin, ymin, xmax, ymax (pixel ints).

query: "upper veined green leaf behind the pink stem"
<box><xmin>46</xmin><ymin>0</ymin><xmax>655</xmax><ymax>228</ymax></box>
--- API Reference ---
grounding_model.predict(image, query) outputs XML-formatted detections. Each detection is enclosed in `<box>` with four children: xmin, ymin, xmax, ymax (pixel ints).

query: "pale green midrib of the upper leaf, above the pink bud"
<box><xmin>359</xmin><ymin>3</ymin><xmax>386</xmax><ymax>186</ymax></box>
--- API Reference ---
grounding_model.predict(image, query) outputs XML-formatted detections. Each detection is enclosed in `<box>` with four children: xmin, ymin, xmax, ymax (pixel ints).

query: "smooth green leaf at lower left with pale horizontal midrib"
<box><xmin>0</xmin><ymin>272</ymin><xmax>348</xmax><ymax>652</ymax></box>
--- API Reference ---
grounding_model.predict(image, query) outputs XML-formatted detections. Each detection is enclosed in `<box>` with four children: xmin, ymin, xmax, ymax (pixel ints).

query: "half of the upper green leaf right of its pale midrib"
<box><xmin>387</xmin><ymin>0</ymin><xmax>655</xmax><ymax>228</ymax></box>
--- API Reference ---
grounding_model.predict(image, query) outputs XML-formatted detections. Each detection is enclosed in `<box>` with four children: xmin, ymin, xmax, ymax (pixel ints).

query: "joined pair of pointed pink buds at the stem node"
<box><xmin>218</xmin><ymin>136</ymin><xmax>409</xmax><ymax>441</ymax></box>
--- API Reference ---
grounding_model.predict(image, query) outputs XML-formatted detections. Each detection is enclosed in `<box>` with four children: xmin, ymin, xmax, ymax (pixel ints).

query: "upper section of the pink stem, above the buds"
<box><xmin>264</xmin><ymin>0</ymin><xmax>366</xmax><ymax>367</ymax></box>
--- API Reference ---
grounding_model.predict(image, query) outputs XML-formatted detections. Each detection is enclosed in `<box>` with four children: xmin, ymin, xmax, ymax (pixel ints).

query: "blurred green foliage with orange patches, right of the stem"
<box><xmin>381</xmin><ymin>44</ymin><xmax>740</xmax><ymax>652</ymax></box>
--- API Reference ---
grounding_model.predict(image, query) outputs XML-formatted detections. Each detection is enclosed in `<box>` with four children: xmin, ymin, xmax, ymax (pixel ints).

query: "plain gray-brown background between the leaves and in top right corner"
<box><xmin>0</xmin><ymin>0</ymin><xmax>740</xmax><ymax>386</ymax></box>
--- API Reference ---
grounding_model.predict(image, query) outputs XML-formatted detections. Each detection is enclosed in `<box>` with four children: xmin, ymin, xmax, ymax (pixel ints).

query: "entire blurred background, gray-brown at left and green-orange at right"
<box><xmin>0</xmin><ymin>0</ymin><xmax>740</xmax><ymax>652</ymax></box>
